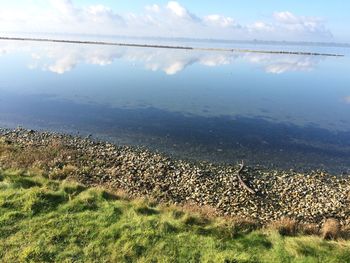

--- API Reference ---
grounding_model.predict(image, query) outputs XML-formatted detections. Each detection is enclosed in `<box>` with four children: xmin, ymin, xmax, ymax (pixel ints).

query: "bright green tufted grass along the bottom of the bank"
<box><xmin>0</xmin><ymin>170</ymin><xmax>350</xmax><ymax>263</ymax></box>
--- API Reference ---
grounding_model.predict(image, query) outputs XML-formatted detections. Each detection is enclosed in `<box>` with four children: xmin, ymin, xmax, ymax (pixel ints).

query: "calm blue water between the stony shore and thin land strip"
<box><xmin>0</xmin><ymin>41</ymin><xmax>350</xmax><ymax>172</ymax></box>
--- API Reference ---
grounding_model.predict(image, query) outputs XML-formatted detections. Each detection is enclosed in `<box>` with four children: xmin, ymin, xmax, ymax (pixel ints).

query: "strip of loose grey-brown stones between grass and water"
<box><xmin>0</xmin><ymin>128</ymin><xmax>350</xmax><ymax>225</ymax></box>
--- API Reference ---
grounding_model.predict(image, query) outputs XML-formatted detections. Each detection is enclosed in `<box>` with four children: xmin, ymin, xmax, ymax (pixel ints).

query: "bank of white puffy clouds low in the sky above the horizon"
<box><xmin>0</xmin><ymin>0</ymin><xmax>332</xmax><ymax>41</ymax></box>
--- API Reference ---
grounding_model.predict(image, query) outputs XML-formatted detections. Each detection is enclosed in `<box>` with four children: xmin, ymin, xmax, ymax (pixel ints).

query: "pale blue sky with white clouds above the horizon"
<box><xmin>0</xmin><ymin>0</ymin><xmax>350</xmax><ymax>43</ymax></box>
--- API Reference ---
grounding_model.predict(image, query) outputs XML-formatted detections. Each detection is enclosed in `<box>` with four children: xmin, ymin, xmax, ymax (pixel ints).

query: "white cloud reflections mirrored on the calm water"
<box><xmin>0</xmin><ymin>41</ymin><xmax>323</xmax><ymax>75</ymax></box>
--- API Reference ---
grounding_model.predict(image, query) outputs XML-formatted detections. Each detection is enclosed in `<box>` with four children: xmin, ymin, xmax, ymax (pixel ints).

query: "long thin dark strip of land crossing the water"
<box><xmin>0</xmin><ymin>37</ymin><xmax>344</xmax><ymax>57</ymax></box>
